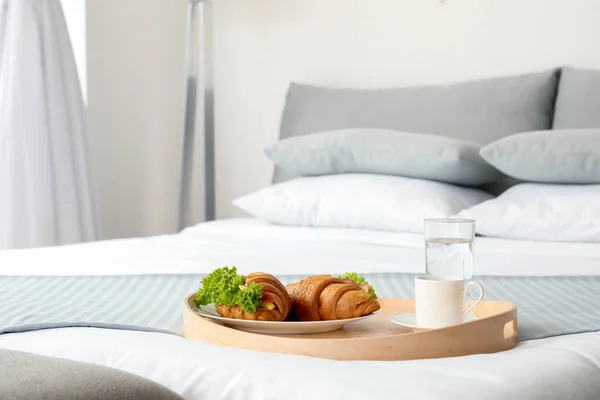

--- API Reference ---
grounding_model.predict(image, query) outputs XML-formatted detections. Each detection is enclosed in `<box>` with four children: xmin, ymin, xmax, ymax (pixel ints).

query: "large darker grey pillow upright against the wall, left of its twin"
<box><xmin>273</xmin><ymin>70</ymin><xmax>558</xmax><ymax>182</ymax></box>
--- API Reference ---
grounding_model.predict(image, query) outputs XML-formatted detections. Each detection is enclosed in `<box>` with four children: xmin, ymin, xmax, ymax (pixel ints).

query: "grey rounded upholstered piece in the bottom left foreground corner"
<box><xmin>0</xmin><ymin>349</ymin><xmax>183</xmax><ymax>400</ymax></box>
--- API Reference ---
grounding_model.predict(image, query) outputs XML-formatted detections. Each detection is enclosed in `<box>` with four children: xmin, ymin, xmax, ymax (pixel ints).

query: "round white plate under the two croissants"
<box><xmin>192</xmin><ymin>305</ymin><xmax>375</xmax><ymax>335</ymax></box>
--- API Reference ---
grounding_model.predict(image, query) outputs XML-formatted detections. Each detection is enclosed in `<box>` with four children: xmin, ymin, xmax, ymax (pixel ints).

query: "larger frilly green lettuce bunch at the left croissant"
<box><xmin>196</xmin><ymin>267</ymin><xmax>262</xmax><ymax>314</ymax></box>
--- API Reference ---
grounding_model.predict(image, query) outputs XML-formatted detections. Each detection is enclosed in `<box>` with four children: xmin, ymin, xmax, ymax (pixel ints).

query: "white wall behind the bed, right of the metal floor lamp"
<box><xmin>214</xmin><ymin>0</ymin><xmax>600</xmax><ymax>217</ymax></box>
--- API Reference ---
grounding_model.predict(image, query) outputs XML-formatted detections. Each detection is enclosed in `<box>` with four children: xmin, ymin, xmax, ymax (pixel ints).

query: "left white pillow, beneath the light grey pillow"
<box><xmin>233</xmin><ymin>174</ymin><xmax>493</xmax><ymax>233</ymax></box>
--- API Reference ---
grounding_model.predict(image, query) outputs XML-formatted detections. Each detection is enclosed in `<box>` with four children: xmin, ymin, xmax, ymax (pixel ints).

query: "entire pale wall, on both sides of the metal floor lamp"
<box><xmin>63</xmin><ymin>0</ymin><xmax>600</xmax><ymax>237</ymax></box>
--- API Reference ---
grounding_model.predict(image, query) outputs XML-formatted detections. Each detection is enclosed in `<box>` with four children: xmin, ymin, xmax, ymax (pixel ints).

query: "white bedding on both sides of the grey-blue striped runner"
<box><xmin>0</xmin><ymin>219</ymin><xmax>600</xmax><ymax>400</ymax></box>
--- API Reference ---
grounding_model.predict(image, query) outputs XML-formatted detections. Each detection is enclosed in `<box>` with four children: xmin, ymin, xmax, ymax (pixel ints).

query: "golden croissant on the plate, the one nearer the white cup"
<box><xmin>285</xmin><ymin>275</ymin><xmax>381</xmax><ymax>321</ymax></box>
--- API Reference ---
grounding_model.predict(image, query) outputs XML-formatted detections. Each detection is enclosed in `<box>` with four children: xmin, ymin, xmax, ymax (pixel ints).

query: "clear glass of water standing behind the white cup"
<box><xmin>425</xmin><ymin>218</ymin><xmax>475</xmax><ymax>302</ymax></box>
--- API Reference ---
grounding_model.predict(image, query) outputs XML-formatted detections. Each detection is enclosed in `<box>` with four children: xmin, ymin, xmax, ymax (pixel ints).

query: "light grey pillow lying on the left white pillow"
<box><xmin>265</xmin><ymin>128</ymin><xmax>501</xmax><ymax>186</ymax></box>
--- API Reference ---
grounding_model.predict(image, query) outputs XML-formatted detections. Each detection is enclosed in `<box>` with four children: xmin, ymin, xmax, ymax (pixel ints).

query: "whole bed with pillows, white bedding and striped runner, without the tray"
<box><xmin>0</xmin><ymin>69</ymin><xmax>600</xmax><ymax>400</ymax></box>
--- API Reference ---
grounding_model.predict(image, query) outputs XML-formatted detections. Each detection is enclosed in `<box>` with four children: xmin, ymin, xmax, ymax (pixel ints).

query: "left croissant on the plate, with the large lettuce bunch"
<box><xmin>217</xmin><ymin>272</ymin><xmax>292</xmax><ymax>321</ymax></box>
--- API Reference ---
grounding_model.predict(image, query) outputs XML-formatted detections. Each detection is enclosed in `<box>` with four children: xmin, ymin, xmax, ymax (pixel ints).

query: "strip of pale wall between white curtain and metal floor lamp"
<box><xmin>86</xmin><ymin>0</ymin><xmax>187</xmax><ymax>238</ymax></box>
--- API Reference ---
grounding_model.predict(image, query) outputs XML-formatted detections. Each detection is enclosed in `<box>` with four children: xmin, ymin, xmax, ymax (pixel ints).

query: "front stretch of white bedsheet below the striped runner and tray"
<box><xmin>0</xmin><ymin>328</ymin><xmax>600</xmax><ymax>400</ymax></box>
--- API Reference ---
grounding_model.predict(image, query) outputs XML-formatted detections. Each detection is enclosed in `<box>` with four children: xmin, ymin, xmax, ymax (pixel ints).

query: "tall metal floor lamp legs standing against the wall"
<box><xmin>178</xmin><ymin>0</ymin><xmax>215</xmax><ymax>230</ymax></box>
